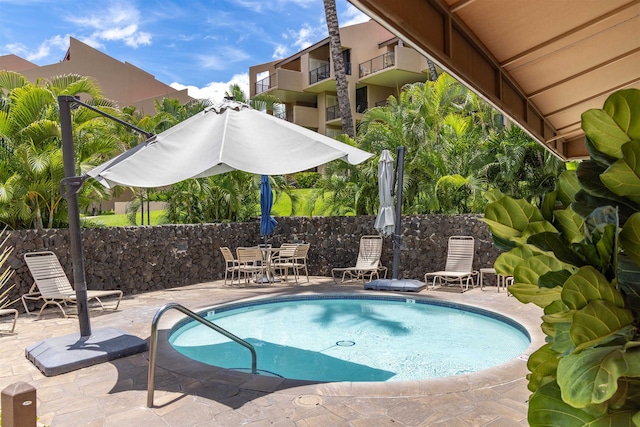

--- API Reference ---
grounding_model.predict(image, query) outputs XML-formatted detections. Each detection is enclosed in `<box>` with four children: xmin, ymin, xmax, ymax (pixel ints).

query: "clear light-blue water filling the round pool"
<box><xmin>169</xmin><ymin>295</ymin><xmax>530</xmax><ymax>381</ymax></box>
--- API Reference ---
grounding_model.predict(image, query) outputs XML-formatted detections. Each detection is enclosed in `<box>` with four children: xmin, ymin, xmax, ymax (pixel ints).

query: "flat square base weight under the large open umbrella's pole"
<box><xmin>25</xmin><ymin>328</ymin><xmax>147</xmax><ymax>377</ymax></box>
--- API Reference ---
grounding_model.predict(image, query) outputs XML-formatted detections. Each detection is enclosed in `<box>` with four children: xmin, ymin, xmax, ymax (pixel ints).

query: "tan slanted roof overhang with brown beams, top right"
<box><xmin>349</xmin><ymin>0</ymin><xmax>640</xmax><ymax>159</ymax></box>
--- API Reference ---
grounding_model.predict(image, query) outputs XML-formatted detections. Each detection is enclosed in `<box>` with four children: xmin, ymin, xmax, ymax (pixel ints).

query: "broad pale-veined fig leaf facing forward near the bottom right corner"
<box><xmin>557</xmin><ymin>343</ymin><xmax>640</xmax><ymax>408</ymax></box>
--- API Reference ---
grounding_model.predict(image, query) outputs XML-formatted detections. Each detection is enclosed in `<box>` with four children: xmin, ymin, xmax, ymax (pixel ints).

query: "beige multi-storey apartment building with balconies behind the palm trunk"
<box><xmin>249</xmin><ymin>20</ymin><xmax>429</xmax><ymax>137</ymax></box>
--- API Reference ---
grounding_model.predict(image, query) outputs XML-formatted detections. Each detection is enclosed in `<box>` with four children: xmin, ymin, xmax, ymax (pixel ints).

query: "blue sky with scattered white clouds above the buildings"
<box><xmin>0</xmin><ymin>0</ymin><xmax>369</xmax><ymax>101</ymax></box>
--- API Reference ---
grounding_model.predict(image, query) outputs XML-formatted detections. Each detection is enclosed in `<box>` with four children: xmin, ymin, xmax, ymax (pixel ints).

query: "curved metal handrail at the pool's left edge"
<box><xmin>147</xmin><ymin>302</ymin><xmax>258</xmax><ymax>408</ymax></box>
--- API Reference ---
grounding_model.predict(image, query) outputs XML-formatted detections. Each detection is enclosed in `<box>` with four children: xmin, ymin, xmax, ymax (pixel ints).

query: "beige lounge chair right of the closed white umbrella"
<box><xmin>424</xmin><ymin>236</ymin><xmax>478</xmax><ymax>292</ymax></box>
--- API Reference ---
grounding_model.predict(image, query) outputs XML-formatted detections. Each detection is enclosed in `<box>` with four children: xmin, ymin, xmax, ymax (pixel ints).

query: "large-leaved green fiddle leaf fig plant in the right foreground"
<box><xmin>484</xmin><ymin>89</ymin><xmax>640</xmax><ymax>427</ymax></box>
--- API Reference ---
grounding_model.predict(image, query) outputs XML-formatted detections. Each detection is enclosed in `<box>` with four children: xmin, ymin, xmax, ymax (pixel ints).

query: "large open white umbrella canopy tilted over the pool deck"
<box><xmin>88</xmin><ymin>100</ymin><xmax>372</xmax><ymax>188</ymax></box>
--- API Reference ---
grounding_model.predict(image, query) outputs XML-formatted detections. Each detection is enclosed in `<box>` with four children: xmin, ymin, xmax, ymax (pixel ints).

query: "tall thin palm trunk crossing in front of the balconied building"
<box><xmin>324</xmin><ymin>0</ymin><xmax>356</xmax><ymax>138</ymax></box>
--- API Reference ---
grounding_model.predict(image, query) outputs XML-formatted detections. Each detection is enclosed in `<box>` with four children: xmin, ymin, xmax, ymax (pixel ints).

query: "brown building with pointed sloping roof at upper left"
<box><xmin>0</xmin><ymin>37</ymin><xmax>192</xmax><ymax>115</ymax></box>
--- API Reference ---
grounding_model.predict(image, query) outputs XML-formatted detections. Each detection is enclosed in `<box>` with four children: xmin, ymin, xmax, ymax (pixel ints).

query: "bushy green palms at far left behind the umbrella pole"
<box><xmin>0</xmin><ymin>71</ymin><xmax>120</xmax><ymax>228</ymax></box>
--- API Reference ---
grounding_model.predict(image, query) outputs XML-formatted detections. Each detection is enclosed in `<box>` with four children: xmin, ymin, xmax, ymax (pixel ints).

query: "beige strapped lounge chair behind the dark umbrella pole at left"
<box><xmin>21</xmin><ymin>251</ymin><xmax>122</xmax><ymax>317</ymax></box>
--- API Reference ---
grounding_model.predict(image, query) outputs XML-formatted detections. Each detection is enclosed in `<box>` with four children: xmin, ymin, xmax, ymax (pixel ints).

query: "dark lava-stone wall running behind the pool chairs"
<box><xmin>6</xmin><ymin>215</ymin><xmax>499</xmax><ymax>310</ymax></box>
